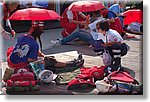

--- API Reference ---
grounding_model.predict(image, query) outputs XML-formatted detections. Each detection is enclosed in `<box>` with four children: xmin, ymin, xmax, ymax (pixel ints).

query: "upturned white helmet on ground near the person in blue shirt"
<box><xmin>39</xmin><ymin>70</ymin><xmax>57</xmax><ymax>83</ymax></box>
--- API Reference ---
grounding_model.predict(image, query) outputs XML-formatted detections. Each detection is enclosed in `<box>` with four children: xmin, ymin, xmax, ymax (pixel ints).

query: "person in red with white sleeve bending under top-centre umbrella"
<box><xmin>60</xmin><ymin>8</ymin><xmax>86</xmax><ymax>37</ymax></box>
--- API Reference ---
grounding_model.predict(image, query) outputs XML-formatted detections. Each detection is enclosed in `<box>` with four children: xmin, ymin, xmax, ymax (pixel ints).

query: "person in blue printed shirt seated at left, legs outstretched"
<box><xmin>7</xmin><ymin>26</ymin><xmax>84</xmax><ymax>69</ymax></box>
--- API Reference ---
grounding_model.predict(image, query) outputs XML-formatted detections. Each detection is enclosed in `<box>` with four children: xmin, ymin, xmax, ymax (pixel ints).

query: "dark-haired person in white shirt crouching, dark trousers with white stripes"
<box><xmin>96</xmin><ymin>21</ymin><xmax>124</xmax><ymax>73</ymax></box>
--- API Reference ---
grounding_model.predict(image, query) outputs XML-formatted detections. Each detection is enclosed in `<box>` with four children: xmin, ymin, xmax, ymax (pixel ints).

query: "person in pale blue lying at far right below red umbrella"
<box><xmin>125</xmin><ymin>22</ymin><xmax>143</xmax><ymax>35</ymax></box>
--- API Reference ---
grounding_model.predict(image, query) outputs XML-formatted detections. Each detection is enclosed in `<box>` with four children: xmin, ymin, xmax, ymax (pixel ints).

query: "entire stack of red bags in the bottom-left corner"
<box><xmin>6</xmin><ymin>69</ymin><xmax>39</xmax><ymax>93</ymax></box>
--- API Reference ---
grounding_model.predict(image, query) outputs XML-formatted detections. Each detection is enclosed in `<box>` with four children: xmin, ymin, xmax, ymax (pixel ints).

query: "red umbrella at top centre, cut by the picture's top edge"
<box><xmin>68</xmin><ymin>1</ymin><xmax>105</xmax><ymax>12</ymax></box>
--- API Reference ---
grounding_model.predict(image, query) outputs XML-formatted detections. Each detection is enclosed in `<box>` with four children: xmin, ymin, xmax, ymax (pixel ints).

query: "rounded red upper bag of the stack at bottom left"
<box><xmin>10</xmin><ymin>72</ymin><xmax>35</xmax><ymax>81</ymax></box>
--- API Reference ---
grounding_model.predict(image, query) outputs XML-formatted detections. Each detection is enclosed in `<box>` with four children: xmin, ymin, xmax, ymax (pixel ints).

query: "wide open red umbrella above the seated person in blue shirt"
<box><xmin>9</xmin><ymin>8</ymin><xmax>60</xmax><ymax>20</ymax></box>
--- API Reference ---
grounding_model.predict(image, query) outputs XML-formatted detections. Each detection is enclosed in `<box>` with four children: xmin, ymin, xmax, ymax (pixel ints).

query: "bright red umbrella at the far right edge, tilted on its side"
<box><xmin>123</xmin><ymin>9</ymin><xmax>143</xmax><ymax>25</ymax></box>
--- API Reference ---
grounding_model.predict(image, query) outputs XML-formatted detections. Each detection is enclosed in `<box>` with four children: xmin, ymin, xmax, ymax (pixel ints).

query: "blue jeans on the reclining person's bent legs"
<box><xmin>61</xmin><ymin>30</ymin><xmax>94</xmax><ymax>44</ymax></box>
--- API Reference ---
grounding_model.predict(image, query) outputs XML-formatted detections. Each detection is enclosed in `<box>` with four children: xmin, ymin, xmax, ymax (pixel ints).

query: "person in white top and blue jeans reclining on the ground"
<box><xmin>51</xmin><ymin>12</ymin><xmax>104</xmax><ymax>45</ymax></box>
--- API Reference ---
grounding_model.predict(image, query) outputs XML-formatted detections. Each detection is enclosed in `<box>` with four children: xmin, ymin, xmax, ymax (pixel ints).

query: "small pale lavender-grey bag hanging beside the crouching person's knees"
<box><xmin>102</xmin><ymin>49</ymin><xmax>112</xmax><ymax>66</ymax></box>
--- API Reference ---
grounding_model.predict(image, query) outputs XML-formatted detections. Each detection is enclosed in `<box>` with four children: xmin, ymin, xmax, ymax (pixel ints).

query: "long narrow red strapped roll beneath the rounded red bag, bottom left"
<box><xmin>7</xmin><ymin>80</ymin><xmax>36</xmax><ymax>87</ymax></box>
